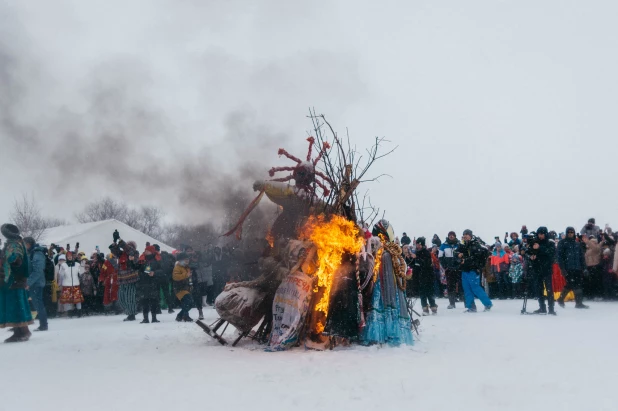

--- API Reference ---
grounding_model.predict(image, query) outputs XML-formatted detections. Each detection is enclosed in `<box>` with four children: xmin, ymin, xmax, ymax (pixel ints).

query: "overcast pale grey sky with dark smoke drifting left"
<box><xmin>0</xmin><ymin>0</ymin><xmax>618</xmax><ymax>240</ymax></box>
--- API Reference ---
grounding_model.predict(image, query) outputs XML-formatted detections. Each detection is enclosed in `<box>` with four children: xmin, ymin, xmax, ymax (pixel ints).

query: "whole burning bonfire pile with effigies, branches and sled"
<box><xmin>198</xmin><ymin>113</ymin><xmax>412</xmax><ymax>351</ymax></box>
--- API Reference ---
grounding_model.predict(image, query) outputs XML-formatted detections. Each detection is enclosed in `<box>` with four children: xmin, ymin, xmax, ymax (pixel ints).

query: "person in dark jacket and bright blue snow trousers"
<box><xmin>457</xmin><ymin>230</ymin><xmax>493</xmax><ymax>312</ymax></box>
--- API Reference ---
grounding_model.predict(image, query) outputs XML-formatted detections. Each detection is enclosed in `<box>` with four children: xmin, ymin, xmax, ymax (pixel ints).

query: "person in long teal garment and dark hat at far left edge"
<box><xmin>0</xmin><ymin>224</ymin><xmax>34</xmax><ymax>343</ymax></box>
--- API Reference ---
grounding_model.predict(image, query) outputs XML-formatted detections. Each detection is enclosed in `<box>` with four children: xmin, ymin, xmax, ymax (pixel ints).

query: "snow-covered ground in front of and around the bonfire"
<box><xmin>0</xmin><ymin>300</ymin><xmax>618</xmax><ymax>411</ymax></box>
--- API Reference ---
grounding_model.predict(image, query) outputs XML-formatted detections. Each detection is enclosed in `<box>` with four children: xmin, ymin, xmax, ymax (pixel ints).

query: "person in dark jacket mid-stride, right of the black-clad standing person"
<box><xmin>558</xmin><ymin>227</ymin><xmax>588</xmax><ymax>308</ymax></box>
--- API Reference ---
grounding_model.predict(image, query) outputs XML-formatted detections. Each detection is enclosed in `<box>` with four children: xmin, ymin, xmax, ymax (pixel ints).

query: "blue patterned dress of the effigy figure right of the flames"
<box><xmin>362</xmin><ymin>250</ymin><xmax>414</xmax><ymax>346</ymax></box>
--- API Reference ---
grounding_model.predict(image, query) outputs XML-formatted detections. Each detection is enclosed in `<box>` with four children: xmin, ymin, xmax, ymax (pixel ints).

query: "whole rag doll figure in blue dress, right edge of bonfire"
<box><xmin>362</xmin><ymin>220</ymin><xmax>414</xmax><ymax>346</ymax></box>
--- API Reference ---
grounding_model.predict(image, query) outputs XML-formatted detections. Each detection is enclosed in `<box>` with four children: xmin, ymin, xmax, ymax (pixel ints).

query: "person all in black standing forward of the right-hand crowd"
<box><xmin>529</xmin><ymin>227</ymin><xmax>556</xmax><ymax>315</ymax></box>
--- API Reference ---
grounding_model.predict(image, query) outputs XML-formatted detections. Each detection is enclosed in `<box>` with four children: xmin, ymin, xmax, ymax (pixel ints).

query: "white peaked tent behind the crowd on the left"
<box><xmin>33</xmin><ymin>220</ymin><xmax>174</xmax><ymax>255</ymax></box>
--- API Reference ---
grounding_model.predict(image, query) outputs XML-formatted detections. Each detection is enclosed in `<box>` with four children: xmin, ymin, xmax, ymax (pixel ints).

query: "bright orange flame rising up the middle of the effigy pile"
<box><xmin>301</xmin><ymin>215</ymin><xmax>364</xmax><ymax>320</ymax></box>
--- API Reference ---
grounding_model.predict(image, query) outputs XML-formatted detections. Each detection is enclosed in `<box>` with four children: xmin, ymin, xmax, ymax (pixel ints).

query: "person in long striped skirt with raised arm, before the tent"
<box><xmin>109</xmin><ymin>235</ymin><xmax>140</xmax><ymax>321</ymax></box>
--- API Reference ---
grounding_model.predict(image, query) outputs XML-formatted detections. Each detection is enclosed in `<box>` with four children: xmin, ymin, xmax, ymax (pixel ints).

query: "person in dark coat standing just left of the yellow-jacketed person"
<box><xmin>135</xmin><ymin>245</ymin><xmax>163</xmax><ymax>324</ymax></box>
